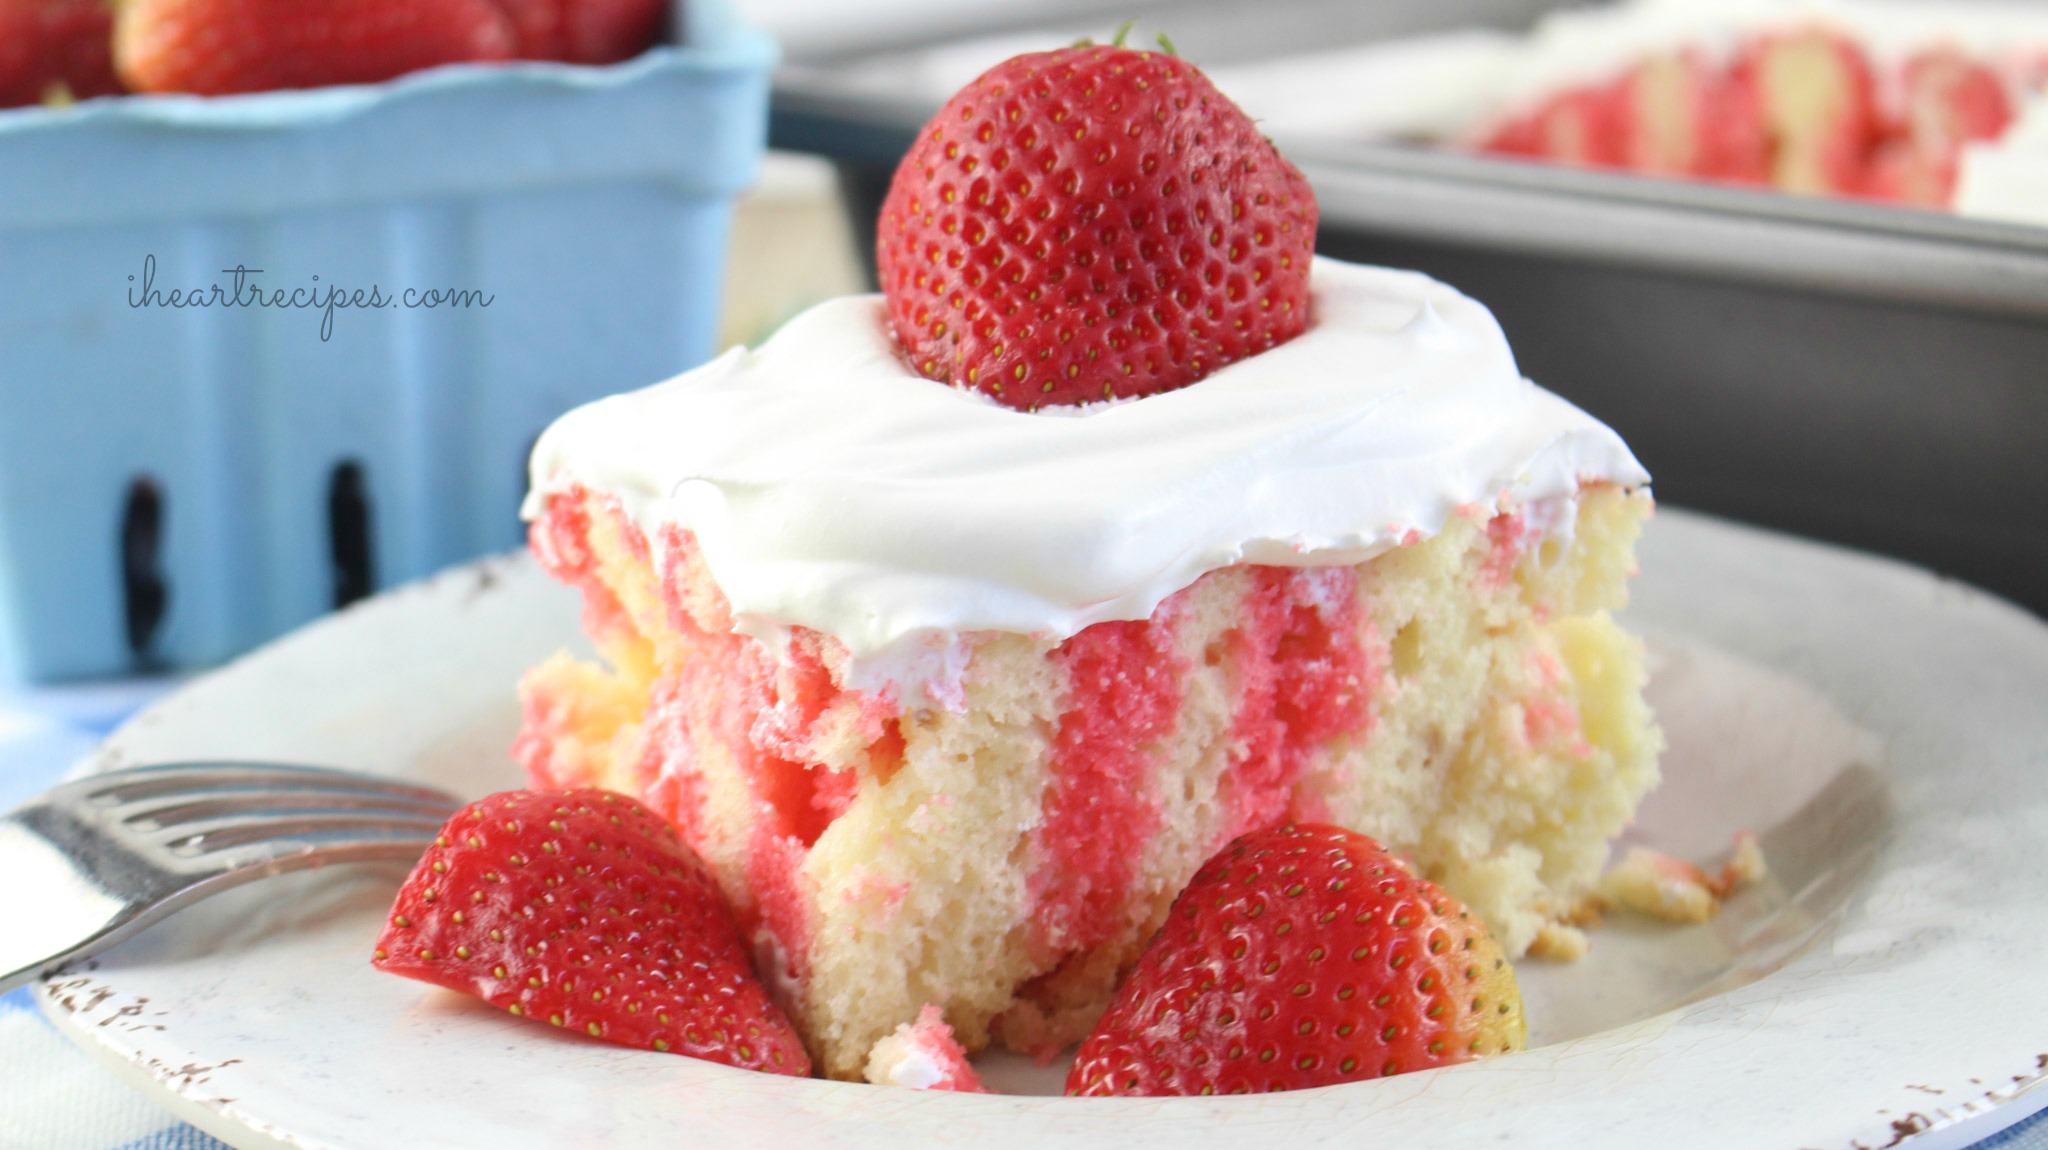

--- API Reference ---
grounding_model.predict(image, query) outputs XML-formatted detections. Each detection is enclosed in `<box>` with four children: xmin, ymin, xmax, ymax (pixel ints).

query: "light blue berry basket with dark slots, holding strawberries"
<box><xmin>0</xmin><ymin>2</ymin><xmax>776</xmax><ymax>681</ymax></box>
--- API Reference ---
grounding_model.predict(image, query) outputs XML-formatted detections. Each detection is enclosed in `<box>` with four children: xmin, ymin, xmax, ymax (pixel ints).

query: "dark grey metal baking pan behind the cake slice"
<box><xmin>770</xmin><ymin>0</ymin><xmax>2048</xmax><ymax>614</ymax></box>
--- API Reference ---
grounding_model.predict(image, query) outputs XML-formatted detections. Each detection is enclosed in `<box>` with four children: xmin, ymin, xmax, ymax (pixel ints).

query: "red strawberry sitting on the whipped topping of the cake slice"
<box><xmin>877</xmin><ymin>47</ymin><xmax>1317</xmax><ymax>409</ymax></box>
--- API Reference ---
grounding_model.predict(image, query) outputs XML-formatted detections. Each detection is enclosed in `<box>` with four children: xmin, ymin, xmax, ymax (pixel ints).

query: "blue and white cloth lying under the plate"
<box><xmin>0</xmin><ymin>681</ymin><xmax>2048</xmax><ymax>1150</ymax></box>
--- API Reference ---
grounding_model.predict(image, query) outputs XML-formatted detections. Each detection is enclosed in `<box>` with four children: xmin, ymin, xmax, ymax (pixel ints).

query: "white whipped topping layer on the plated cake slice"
<box><xmin>526</xmin><ymin>260</ymin><xmax>1649</xmax><ymax>706</ymax></box>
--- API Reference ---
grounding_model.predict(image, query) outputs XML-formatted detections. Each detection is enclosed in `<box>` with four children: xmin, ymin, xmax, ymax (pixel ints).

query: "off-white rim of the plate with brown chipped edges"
<box><xmin>39</xmin><ymin>507</ymin><xmax>2048</xmax><ymax>1150</ymax></box>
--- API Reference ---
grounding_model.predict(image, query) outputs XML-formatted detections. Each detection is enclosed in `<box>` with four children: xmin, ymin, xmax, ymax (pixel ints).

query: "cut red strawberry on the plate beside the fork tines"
<box><xmin>373</xmin><ymin>790</ymin><xmax>811</xmax><ymax>1076</ymax></box>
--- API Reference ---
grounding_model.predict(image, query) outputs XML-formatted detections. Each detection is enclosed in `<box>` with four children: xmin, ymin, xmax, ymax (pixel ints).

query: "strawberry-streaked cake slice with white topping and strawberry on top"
<box><xmin>518</xmin><ymin>31</ymin><xmax>1661</xmax><ymax>1078</ymax></box>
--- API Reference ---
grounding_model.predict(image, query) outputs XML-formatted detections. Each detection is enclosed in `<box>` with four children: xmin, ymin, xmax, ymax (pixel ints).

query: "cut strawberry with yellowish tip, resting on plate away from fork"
<box><xmin>1067</xmin><ymin>825</ymin><xmax>1526</xmax><ymax>1095</ymax></box>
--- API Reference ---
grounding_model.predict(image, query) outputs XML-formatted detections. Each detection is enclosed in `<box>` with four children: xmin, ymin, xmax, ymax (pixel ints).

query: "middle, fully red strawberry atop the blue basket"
<box><xmin>115</xmin><ymin>0</ymin><xmax>514</xmax><ymax>96</ymax></box>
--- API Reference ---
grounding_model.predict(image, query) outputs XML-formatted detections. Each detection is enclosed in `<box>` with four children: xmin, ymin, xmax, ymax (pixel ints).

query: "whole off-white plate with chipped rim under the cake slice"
<box><xmin>28</xmin><ymin>512</ymin><xmax>2048</xmax><ymax>1150</ymax></box>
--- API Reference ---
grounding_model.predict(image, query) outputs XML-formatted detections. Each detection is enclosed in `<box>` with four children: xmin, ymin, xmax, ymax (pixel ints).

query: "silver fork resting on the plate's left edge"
<box><xmin>0</xmin><ymin>763</ymin><xmax>461</xmax><ymax>994</ymax></box>
